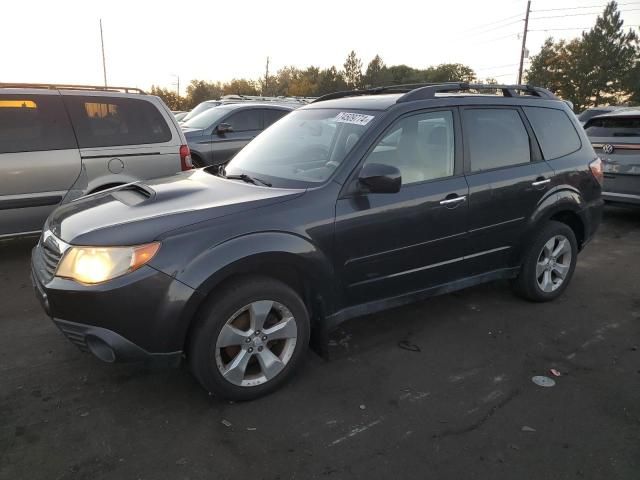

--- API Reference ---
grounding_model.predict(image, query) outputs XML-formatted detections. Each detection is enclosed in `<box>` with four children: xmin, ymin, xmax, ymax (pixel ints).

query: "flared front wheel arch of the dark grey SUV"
<box><xmin>176</xmin><ymin>231</ymin><xmax>337</xmax><ymax>312</ymax></box>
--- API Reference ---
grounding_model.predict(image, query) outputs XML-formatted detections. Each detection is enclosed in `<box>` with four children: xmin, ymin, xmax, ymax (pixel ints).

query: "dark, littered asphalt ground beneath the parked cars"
<box><xmin>0</xmin><ymin>208</ymin><xmax>640</xmax><ymax>480</ymax></box>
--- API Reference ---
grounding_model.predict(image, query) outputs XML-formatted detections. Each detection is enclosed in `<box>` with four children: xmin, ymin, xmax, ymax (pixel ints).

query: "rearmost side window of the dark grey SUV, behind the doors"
<box><xmin>524</xmin><ymin>107</ymin><xmax>582</xmax><ymax>160</ymax></box>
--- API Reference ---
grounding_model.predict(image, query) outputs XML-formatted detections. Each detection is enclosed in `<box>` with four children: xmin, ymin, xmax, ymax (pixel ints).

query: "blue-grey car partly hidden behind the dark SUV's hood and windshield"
<box><xmin>182</xmin><ymin>102</ymin><xmax>295</xmax><ymax>167</ymax></box>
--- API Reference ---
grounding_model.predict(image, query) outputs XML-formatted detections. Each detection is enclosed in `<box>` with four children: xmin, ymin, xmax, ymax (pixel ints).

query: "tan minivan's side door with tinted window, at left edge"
<box><xmin>0</xmin><ymin>92</ymin><xmax>81</xmax><ymax>237</ymax></box>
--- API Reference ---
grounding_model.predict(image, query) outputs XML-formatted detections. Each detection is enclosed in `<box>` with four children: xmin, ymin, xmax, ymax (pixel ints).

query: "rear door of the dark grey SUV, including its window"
<box><xmin>462</xmin><ymin>107</ymin><xmax>554</xmax><ymax>275</ymax></box>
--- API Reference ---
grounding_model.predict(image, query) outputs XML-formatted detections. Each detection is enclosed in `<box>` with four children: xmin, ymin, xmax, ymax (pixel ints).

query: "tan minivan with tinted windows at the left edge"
<box><xmin>0</xmin><ymin>84</ymin><xmax>191</xmax><ymax>238</ymax></box>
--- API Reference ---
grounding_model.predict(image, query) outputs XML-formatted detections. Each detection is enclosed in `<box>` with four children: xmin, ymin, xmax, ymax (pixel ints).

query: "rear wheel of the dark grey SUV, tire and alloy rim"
<box><xmin>515</xmin><ymin>221</ymin><xmax>578</xmax><ymax>302</ymax></box>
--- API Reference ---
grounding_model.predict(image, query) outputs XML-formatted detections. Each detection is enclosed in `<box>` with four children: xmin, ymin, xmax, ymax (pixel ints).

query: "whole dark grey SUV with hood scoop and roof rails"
<box><xmin>32</xmin><ymin>83</ymin><xmax>602</xmax><ymax>400</ymax></box>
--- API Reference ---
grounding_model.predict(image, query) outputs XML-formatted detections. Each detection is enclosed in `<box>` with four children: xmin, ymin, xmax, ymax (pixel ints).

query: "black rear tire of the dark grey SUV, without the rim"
<box><xmin>513</xmin><ymin>221</ymin><xmax>578</xmax><ymax>302</ymax></box>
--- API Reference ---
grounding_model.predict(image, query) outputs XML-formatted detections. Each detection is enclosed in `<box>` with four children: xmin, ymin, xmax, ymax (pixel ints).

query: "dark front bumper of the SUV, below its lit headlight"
<box><xmin>31</xmin><ymin>246</ymin><xmax>198</xmax><ymax>365</ymax></box>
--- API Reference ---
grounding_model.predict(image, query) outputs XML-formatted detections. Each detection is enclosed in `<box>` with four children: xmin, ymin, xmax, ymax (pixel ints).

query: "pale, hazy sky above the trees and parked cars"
<box><xmin>0</xmin><ymin>0</ymin><xmax>640</xmax><ymax>94</ymax></box>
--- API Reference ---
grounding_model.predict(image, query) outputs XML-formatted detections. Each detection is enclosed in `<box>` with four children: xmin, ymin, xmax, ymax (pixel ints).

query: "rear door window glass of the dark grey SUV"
<box><xmin>463</xmin><ymin>108</ymin><xmax>531</xmax><ymax>172</ymax></box>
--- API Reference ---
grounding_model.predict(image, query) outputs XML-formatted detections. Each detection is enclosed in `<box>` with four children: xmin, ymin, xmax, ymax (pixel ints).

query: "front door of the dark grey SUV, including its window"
<box><xmin>335</xmin><ymin>110</ymin><xmax>468</xmax><ymax>305</ymax></box>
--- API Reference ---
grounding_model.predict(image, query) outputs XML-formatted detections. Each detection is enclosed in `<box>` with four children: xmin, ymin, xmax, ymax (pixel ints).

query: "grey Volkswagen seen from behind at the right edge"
<box><xmin>584</xmin><ymin>108</ymin><xmax>640</xmax><ymax>205</ymax></box>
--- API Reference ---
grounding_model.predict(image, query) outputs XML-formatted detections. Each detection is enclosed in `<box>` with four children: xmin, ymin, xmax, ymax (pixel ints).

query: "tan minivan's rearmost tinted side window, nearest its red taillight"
<box><xmin>65</xmin><ymin>96</ymin><xmax>171</xmax><ymax>148</ymax></box>
